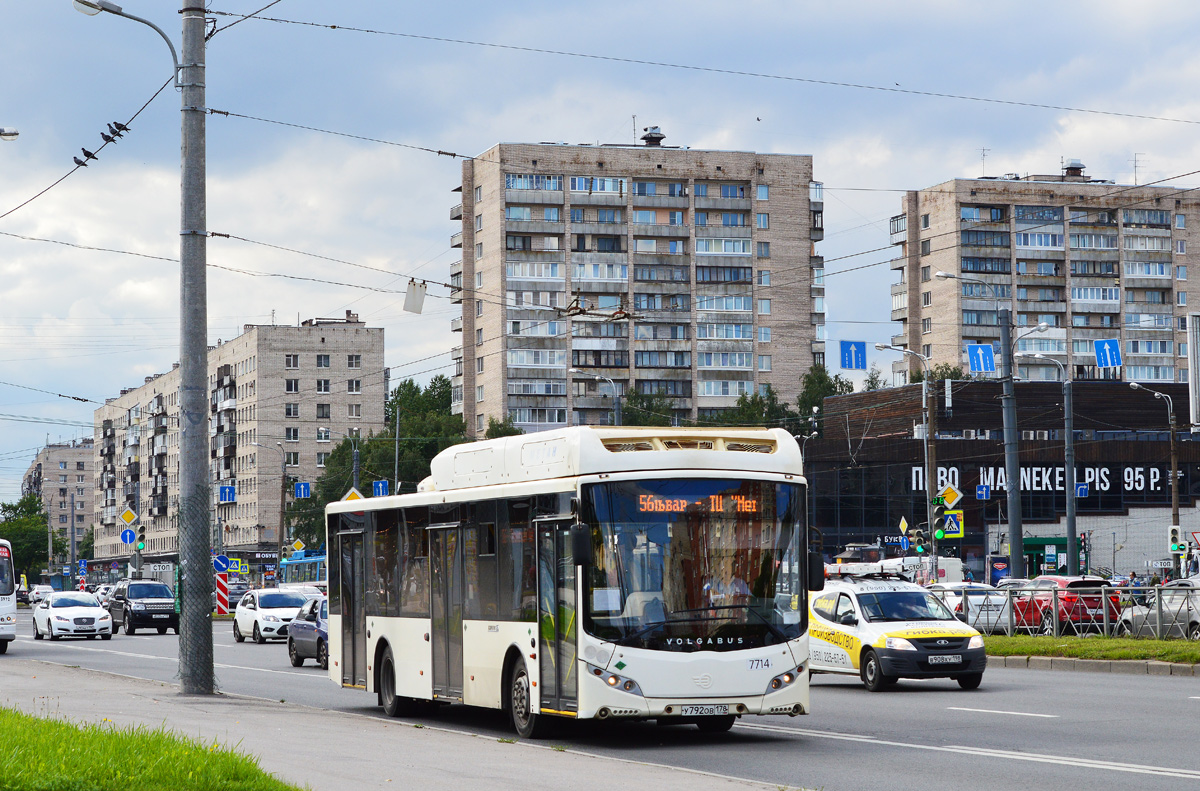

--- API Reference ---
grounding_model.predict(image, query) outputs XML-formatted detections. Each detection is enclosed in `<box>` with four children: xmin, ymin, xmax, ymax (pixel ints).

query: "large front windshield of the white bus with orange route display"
<box><xmin>583</xmin><ymin>479</ymin><xmax>806</xmax><ymax>652</ymax></box>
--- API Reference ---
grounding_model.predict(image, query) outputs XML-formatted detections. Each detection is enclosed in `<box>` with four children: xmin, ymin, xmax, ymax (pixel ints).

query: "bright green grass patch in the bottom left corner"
<box><xmin>0</xmin><ymin>707</ymin><xmax>299</xmax><ymax>791</ymax></box>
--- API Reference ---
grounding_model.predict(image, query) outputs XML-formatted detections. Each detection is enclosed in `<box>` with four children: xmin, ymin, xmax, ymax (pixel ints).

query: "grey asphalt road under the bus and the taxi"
<box><xmin>9</xmin><ymin>611</ymin><xmax>1200</xmax><ymax>791</ymax></box>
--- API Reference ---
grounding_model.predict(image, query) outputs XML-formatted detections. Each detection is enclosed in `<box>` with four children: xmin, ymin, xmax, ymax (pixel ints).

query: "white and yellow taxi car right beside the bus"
<box><xmin>809</xmin><ymin>574</ymin><xmax>988</xmax><ymax>693</ymax></box>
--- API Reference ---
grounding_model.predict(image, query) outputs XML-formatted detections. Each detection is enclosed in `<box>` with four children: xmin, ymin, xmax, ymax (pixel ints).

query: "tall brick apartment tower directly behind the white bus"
<box><xmin>450</xmin><ymin>127</ymin><xmax>824</xmax><ymax>436</ymax></box>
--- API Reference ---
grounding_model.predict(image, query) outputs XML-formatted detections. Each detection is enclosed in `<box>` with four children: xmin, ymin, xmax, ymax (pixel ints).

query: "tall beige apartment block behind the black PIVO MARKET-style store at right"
<box><xmin>890</xmin><ymin>160</ymin><xmax>1200</xmax><ymax>382</ymax></box>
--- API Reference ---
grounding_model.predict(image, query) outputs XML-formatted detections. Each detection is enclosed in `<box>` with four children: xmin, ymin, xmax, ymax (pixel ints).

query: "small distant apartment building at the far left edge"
<box><xmin>20</xmin><ymin>437</ymin><xmax>95</xmax><ymax>561</ymax></box>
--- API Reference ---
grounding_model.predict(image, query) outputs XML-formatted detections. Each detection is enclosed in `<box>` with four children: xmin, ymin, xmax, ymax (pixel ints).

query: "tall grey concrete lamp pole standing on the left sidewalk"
<box><xmin>179</xmin><ymin>0</ymin><xmax>215</xmax><ymax>695</ymax></box>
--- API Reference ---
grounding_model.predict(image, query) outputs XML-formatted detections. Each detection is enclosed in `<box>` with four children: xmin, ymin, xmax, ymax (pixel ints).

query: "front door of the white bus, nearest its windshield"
<box><xmin>536</xmin><ymin>520</ymin><xmax>578</xmax><ymax>713</ymax></box>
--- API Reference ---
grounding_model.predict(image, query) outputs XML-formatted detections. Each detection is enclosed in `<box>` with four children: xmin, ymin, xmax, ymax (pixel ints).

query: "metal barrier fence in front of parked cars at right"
<box><xmin>934</xmin><ymin>585</ymin><xmax>1200</xmax><ymax>640</ymax></box>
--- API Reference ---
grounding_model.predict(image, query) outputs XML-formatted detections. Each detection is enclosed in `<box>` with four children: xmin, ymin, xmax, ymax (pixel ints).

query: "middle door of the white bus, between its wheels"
<box><xmin>430</xmin><ymin>525</ymin><xmax>463</xmax><ymax>701</ymax></box>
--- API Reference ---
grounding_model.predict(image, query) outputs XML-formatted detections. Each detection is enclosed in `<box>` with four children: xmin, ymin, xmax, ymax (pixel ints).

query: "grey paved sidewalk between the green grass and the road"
<box><xmin>0</xmin><ymin>657</ymin><xmax>778</xmax><ymax>791</ymax></box>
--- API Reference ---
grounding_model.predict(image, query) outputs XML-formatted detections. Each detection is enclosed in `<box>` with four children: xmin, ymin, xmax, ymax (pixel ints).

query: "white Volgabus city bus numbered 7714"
<box><xmin>326</xmin><ymin>426</ymin><xmax>823</xmax><ymax>737</ymax></box>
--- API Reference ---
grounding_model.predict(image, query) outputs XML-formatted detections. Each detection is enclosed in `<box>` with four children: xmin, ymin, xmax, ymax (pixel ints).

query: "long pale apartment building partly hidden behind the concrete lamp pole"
<box><xmin>94</xmin><ymin>311</ymin><xmax>386</xmax><ymax>559</ymax></box>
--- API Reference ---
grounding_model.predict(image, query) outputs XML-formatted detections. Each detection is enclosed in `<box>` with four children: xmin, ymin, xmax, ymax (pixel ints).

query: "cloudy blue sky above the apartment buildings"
<box><xmin>0</xmin><ymin>0</ymin><xmax>1200</xmax><ymax>501</ymax></box>
